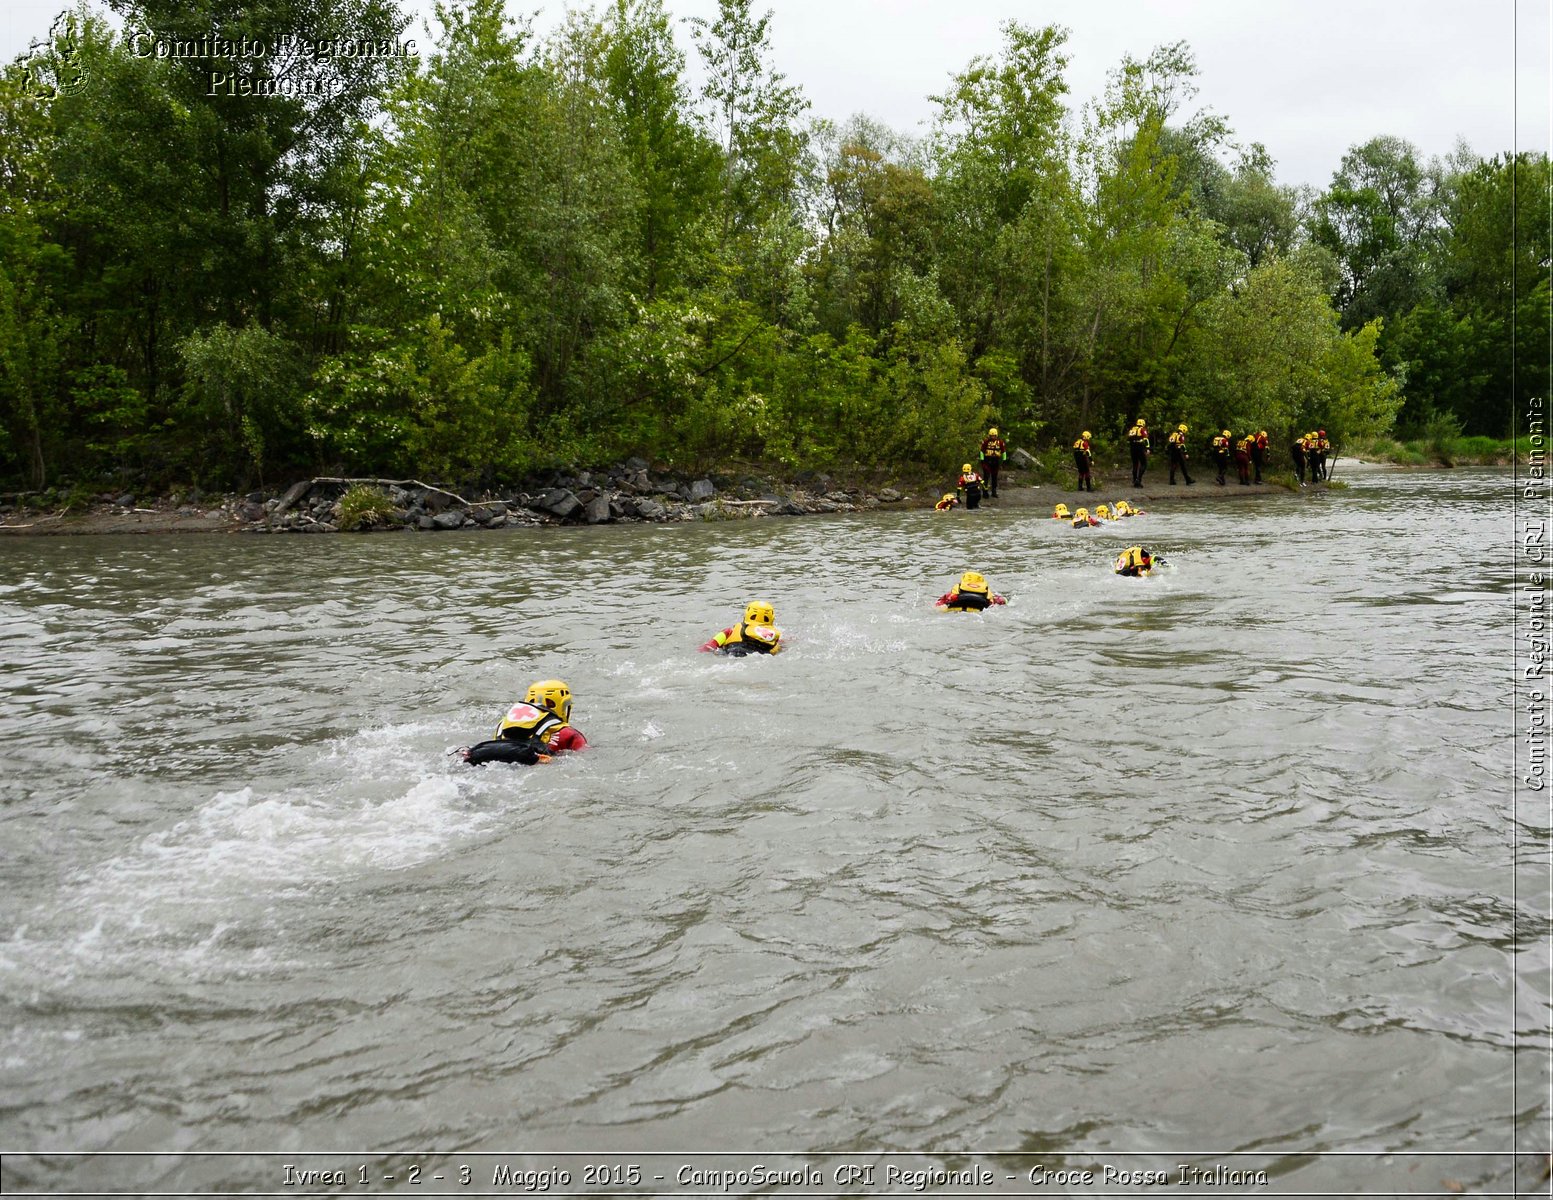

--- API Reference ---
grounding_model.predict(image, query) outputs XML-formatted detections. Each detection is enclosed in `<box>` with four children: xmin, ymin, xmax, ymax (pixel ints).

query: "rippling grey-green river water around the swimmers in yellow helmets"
<box><xmin>0</xmin><ymin>470</ymin><xmax>1550</xmax><ymax>1194</ymax></box>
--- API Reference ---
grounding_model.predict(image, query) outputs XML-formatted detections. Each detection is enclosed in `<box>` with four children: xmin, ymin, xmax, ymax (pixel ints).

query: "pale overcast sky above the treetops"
<box><xmin>0</xmin><ymin>0</ymin><xmax>1553</xmax><ymax>188</ymax></box>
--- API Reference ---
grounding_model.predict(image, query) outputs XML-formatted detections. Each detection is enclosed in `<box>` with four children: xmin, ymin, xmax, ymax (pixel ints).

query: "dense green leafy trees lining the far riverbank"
<box><xmin>0</xmin><ymin>0</ymin><xmax>1550</xmax><ymax>487</ymax></box>
